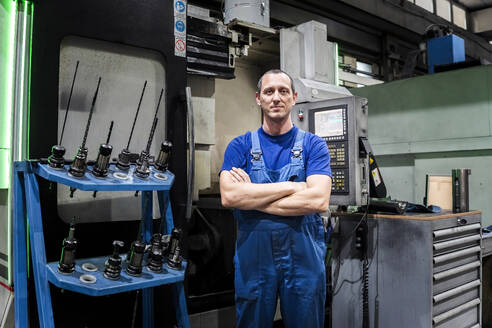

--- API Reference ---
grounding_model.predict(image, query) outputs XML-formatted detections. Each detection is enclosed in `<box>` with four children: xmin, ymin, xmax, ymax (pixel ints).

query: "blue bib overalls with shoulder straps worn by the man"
<box><xmin>234</xmin><ymin>130</ymin><xmax>326</xmax><ymax>328</ymax></box>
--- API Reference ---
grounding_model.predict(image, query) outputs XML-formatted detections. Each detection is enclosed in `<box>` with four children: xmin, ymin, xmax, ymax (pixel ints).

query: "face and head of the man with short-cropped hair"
<box><xmin>256</xmin><ymin>73</ymin><xmax>297</xmax><ymax>122</ymax></box>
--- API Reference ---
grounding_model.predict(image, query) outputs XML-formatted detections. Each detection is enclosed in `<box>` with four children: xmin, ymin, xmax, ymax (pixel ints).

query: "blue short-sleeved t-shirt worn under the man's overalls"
<box><xmin>220</xmin><ymin>126</ymin><xmax>331</xmax><ymax>177</ymax></box>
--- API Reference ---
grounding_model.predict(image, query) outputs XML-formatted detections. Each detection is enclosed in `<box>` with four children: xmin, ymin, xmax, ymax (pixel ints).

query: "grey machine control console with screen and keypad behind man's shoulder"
<box><xmin>291</xmin><ymin>96</ymin><xmax>369</xmax><ymax>206</ymax></box>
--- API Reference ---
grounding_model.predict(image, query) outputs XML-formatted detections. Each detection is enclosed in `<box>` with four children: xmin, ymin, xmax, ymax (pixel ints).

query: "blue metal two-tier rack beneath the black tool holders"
<box><xmin>13</xmin><ymin>161</ymin><xmax>190</xmax><ymax>328</ymax></box>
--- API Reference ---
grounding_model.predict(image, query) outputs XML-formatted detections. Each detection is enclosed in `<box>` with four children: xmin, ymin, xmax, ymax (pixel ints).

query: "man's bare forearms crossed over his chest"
<box><xmin>220</xmin><ymin>168</ymin><xmax>331</xmax><ymax>216</ymax></box>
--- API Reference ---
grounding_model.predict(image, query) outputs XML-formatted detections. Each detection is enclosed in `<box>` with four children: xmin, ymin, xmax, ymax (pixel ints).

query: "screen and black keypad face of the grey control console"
<box><xmin>309</xmin><ymin>105</ymin><xmax>350</xmax><ymax>195</ymax></box>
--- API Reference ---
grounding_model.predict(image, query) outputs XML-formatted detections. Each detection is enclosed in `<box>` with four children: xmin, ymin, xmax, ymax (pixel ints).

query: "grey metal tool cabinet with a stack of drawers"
<box><xmin>331</xmin><ymin>211</ymin><xmax>482</xmax><ymax>328</ymax></box>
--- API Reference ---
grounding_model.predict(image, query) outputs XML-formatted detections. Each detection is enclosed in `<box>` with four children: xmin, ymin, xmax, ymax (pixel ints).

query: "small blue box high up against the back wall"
<box><xmin>427</xmin><ymin>34</ymin><xmax>465</xmax><ymax>73</ymax></box>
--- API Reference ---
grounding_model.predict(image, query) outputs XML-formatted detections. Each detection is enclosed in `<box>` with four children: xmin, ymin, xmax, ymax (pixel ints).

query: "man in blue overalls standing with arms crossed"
<box><xmin>220</xmin><ymin>70</ymin><xmax>331</xmax><ymax>328</ymax></box>
